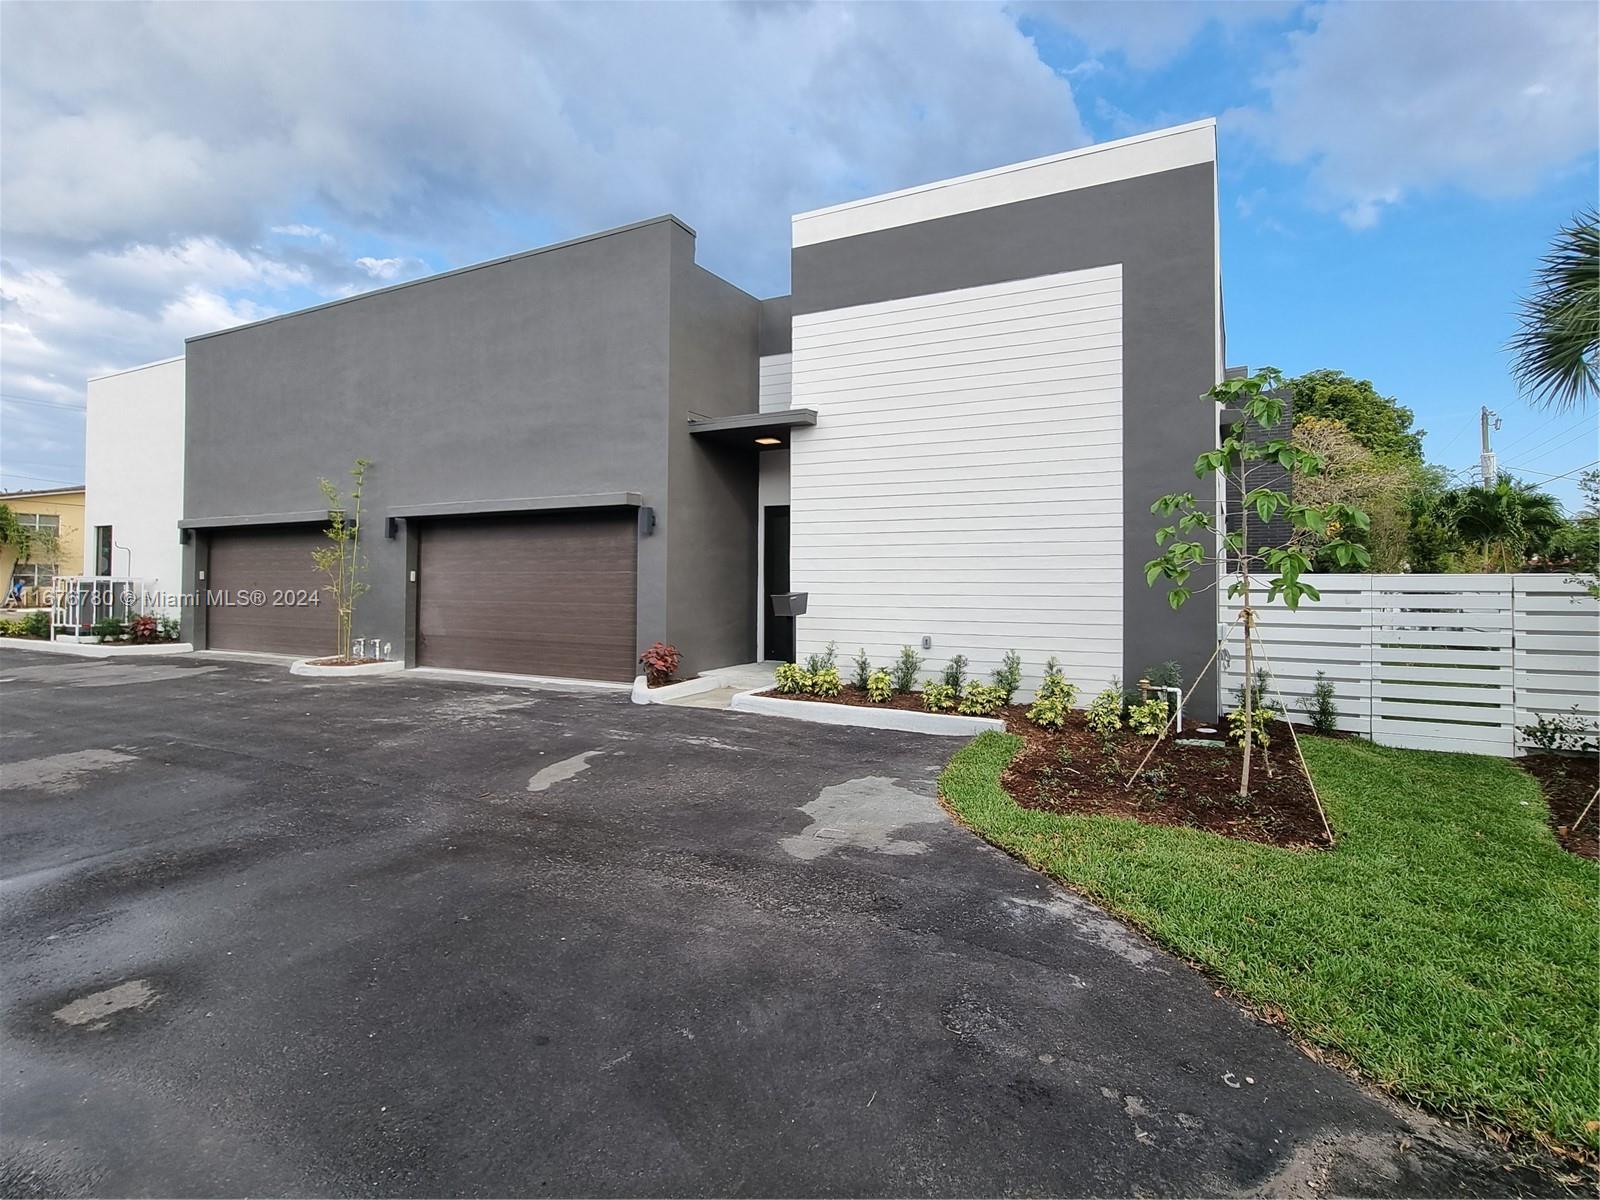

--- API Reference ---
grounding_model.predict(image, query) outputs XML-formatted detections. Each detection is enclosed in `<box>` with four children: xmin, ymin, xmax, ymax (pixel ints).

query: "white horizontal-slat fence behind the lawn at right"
<box><xmin>1219</xmin><ymin>574</ymin><xmax>1600</xmax><ymax>757</ymax></box>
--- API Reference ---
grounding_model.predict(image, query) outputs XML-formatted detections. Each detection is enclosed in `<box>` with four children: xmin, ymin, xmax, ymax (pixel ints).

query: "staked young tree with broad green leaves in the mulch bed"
<box><xmin>1144</xmin><ymin>366</ymin><xmax>1371</xmax><ymax>795</ymax></box>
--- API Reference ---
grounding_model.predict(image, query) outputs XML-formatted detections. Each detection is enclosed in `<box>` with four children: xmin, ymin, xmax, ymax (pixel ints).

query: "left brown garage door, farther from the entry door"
<box><xmin>205</xmin><ymin>526</ymin><xmax>338</xmax><ymax>656</ymax></box>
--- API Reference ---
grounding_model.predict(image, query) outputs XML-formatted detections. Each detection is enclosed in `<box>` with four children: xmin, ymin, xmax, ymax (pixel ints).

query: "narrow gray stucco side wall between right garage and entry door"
<box><xmin>666</xmin><ymin>227</ymin><xmax>762</xmax><ymax>677</ymax></box>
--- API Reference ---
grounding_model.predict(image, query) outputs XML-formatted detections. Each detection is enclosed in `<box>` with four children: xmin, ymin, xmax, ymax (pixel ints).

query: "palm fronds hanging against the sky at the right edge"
<box><xmin>1506</xmin><ymin>208</ymin><xmax>1600</xmax><ymax>411</ymax></box>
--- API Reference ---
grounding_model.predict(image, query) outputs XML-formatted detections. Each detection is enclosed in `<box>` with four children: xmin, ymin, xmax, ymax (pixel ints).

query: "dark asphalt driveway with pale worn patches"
<box><xmin>0</xmin><ymin>651</ymin><xmax>1536</xmax><ymax>1195</ymax></box>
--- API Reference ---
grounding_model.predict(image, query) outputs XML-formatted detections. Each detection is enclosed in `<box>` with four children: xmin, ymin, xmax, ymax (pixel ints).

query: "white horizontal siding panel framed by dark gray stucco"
<box><xmin>790</xmin><ymin>264</ymin><xmax>1123</xmax><ymax>690</ymax></box>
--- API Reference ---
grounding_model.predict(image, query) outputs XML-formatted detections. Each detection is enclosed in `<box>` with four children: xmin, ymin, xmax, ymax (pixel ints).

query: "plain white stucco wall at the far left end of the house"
<box><xmin>83</xmin><ymin>350</ymin><xmax>184</xmax><ymax>614</ymax></box>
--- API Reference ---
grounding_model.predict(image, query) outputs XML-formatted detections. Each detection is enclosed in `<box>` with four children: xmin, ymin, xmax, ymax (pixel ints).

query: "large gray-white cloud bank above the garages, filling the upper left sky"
<box><xmin>0</xmin><ymin>3</ymin><xmax>1086</xmax><ymax>483</ymax></box>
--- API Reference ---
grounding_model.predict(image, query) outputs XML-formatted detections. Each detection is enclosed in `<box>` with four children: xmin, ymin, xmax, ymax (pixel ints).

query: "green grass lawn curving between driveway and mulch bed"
<box><xmin>941</xmin><ymin>733</ymin><xmax>1600</xmax><ymax>1150</ymax></box>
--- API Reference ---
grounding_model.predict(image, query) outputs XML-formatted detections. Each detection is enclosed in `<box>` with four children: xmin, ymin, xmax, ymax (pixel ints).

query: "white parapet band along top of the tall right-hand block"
<box><xmin>790</xmin><ymin>117</ymin><xmax>1216</xmax><ymax>248</ymax></box>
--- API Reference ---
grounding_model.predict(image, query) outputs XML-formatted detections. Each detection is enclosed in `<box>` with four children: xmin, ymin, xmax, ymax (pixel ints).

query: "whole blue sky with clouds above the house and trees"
<box><xmin>0</xmin><ymin>3</ymin><xmax>1600</xmax><ymax>504</ymax></box>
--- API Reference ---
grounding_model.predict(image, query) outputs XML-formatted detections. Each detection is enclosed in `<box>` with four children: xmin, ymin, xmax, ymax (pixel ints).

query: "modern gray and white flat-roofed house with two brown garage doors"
<box><xmin>90</xmin><ymin>122</ymin><xmax>1222</xmax><ymax>710</ymax></box>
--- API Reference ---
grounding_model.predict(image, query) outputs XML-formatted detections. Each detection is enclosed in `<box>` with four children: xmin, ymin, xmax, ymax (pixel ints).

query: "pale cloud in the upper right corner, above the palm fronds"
<box><xmin>1227</xmin><ymin>2</ymin><xmax>1600</xmax><ymax>229</ymax></box>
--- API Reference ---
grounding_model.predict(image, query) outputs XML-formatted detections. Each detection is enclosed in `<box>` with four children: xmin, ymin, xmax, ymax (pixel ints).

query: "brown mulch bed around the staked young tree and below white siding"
<box><xmin>762</xmin><ymin>685</ymin><xmax>1324</xmax><ymax>848</ymax></box>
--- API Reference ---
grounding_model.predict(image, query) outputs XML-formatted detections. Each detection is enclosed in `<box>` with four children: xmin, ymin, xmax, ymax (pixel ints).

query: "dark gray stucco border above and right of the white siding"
<box><xmin>792</xmin><ymin>163</ymin><xmax>1219</xmax><ymax>715</ymax></box>
